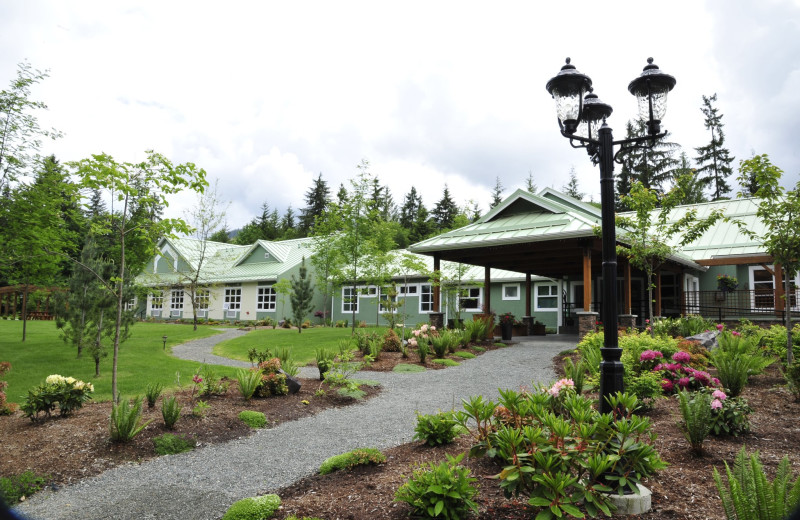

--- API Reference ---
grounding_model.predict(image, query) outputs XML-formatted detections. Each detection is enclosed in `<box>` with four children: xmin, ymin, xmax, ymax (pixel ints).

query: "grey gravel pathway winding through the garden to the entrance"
<box><xmin>18</xmin><ymin>331</ymin><xmax>575</xmax><ymax>520</ymax></box>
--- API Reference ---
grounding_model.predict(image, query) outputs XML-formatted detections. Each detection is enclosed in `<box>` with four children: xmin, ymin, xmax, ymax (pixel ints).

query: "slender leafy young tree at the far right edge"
<box><xmin>739</xmin><ymin>154</ymin><xmax>800</xmax><ymax>366</ymax></box>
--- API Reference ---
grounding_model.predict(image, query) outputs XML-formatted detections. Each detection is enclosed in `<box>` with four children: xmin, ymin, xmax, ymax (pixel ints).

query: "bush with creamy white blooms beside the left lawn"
<box><xmin>20</xmin><ymin>374</ymin><xmax>94</xmax><ymax>421</ymax></box>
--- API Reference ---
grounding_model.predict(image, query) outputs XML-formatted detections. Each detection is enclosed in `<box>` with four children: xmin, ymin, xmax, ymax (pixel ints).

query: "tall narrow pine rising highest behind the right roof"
<box><xmin>695</xmin><ymin>94</ymin><xmax>734</xmax><ymax>200</ymax></box>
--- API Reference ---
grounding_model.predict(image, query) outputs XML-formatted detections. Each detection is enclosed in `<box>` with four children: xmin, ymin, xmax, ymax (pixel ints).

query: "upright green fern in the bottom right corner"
<box><xmin>713</xmin><ymin>446</ymin><xmax>800</xmax><ymax>520</ymax></box>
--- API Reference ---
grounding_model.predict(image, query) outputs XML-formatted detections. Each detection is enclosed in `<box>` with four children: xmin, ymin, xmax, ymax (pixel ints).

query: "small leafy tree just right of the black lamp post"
<box><xmin>616</xmin><ymin>177</ymin><xmax>723</xmax><ymax>328</ymax></box>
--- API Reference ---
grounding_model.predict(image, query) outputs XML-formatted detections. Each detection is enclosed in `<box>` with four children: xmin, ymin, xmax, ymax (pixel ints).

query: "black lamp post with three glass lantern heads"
<box><xmin>547</xmin><ymin>58</ymin><xmax>675</xmax><ymax>413</ymax></box>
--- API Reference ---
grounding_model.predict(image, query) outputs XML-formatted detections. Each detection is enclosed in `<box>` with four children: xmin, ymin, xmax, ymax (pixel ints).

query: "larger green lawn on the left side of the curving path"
<box><xmin>0</xmin><ymin>320</ymin><xmax>238</xmax><ymax>403</ymax></box>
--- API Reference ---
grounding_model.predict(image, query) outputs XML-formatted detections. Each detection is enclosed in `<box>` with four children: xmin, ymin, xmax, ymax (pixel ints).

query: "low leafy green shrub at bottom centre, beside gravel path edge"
<box><xmin>394</xmin><ymin>453</ymin><xmax>478</xmax><ymax>520</ymax></box>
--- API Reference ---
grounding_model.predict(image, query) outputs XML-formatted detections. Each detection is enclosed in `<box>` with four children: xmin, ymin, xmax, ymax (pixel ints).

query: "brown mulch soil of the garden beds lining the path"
<box><xmin>0</xmin><ymin>345</ymin><xmax>800</xmax><ymax>520</ymax></box>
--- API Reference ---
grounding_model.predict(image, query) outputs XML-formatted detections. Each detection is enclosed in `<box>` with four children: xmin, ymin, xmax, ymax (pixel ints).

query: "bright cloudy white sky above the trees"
<box><xmin>0</xmin><ymin>0</ymin><xmax>800</xmax><ymax>228</ymax></box>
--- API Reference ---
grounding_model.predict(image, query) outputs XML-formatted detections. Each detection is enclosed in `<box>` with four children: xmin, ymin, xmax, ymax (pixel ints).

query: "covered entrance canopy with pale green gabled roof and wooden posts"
<box><xmin>409</xmin><ymin>188</ymin><xmax>705</xmax><ymax>324</ymax></box>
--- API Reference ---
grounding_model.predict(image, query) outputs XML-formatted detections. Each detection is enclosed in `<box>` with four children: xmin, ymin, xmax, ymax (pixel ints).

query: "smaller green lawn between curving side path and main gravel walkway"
<box><xmin>214</xmin><ymin>327</ymin><xmax>386</xmax><ymax>365</ymax></box>
